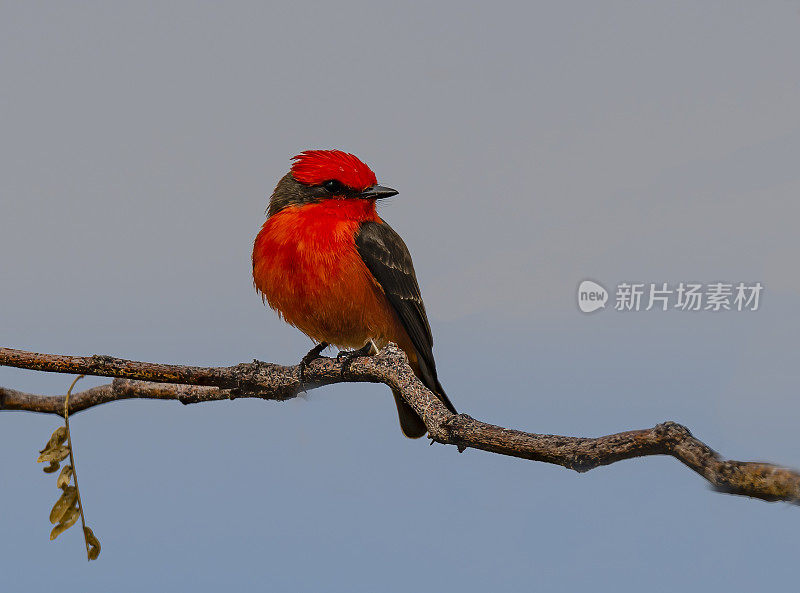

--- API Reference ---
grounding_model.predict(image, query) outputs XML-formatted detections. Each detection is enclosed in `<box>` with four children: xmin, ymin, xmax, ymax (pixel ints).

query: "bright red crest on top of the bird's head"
<box><xmin>292</xmin><ymin>150</ymin><xmax>378</xmax><ymax>190</ymax></box>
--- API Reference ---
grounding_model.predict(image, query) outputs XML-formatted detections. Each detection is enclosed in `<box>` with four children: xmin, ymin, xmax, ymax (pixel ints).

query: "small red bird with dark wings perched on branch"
<box><xmin>253</xmin><ymin>150</ymin><xmax>456</xmax><ymax>438</ymax></box>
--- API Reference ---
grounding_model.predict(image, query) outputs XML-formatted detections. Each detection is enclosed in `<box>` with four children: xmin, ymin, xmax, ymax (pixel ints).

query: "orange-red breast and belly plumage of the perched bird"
<box><xmin>253</xmin><ymin>199</ymin><xmax>404</xmax><ymax>348</ymax></box>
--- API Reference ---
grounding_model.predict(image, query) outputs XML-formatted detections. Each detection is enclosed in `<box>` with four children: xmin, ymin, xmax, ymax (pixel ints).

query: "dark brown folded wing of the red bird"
<box><xmin>356</xmin><ymin>222</ymin><xmax>457</xmax><ymax>414</ymax></box>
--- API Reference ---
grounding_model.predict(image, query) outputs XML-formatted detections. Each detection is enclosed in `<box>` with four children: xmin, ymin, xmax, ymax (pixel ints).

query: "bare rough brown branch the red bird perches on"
<box><xmin>0</xmin><ymin>345</ymin><xmax>800</xmax><ymax>504</ymax></box>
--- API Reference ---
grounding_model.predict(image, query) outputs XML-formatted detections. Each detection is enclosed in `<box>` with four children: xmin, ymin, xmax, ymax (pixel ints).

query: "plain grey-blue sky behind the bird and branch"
<box><xmin>0</xmin><ymin>1</ymin><xmax>800</xmax><ymax>592</ymax></box>
